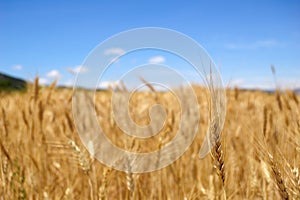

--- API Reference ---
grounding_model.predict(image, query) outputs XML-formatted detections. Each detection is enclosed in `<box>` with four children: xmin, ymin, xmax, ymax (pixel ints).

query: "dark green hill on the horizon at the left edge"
<box><xmin>0</xmin><ymin>73</ymin><xmax>27</xmax><ymax>91</ymax></box>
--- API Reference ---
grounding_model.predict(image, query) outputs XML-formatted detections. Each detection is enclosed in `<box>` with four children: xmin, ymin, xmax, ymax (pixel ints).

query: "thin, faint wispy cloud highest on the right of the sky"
<box><xmin>225</xmin><ymin>40</ymin><xmax>282</xmax><ymax>50</ymax></box>
